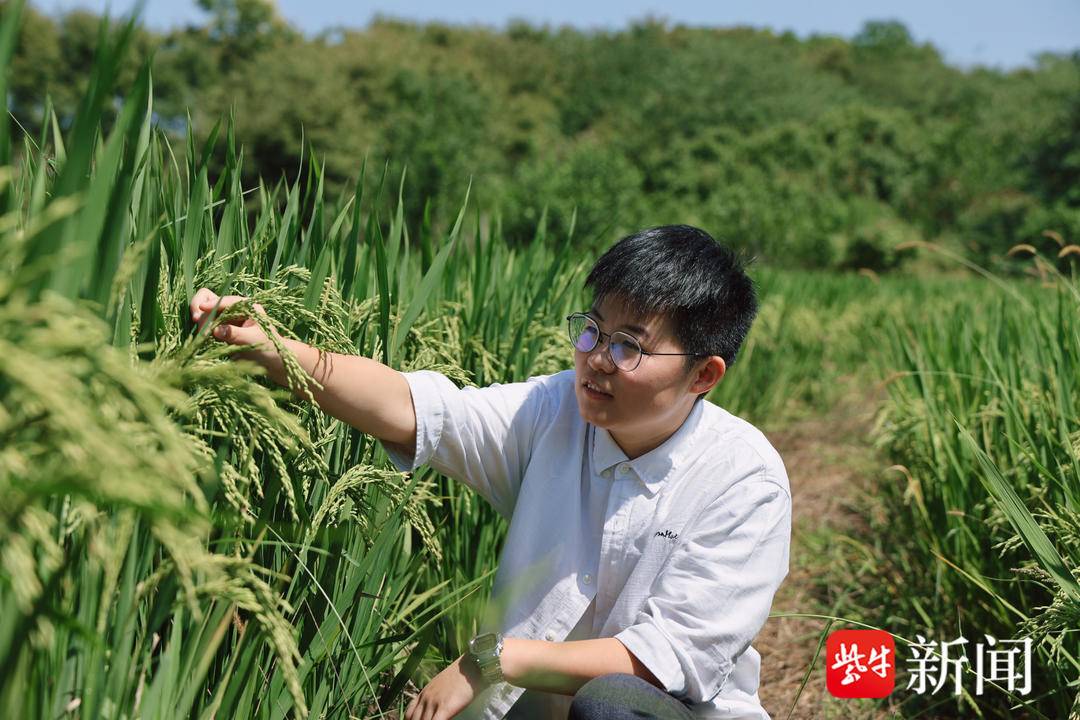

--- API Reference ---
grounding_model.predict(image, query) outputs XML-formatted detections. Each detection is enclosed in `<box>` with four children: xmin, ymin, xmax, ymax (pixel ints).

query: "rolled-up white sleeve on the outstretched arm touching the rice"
<box><xmin>383</xmin><ymin>370</ymin><xmax>548</xmax><ymax>519</ymax></box>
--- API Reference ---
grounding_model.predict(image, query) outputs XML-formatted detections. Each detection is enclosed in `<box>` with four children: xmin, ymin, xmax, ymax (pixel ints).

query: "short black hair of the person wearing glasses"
<box><xmin>585</xmin><ymin>225</ymin><xmax>758</xmax><ymax>371</ymax></box>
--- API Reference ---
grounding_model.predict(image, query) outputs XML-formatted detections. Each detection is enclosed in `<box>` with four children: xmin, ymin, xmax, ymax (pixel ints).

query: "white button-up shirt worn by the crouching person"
<box><xmin>387</xmin><ymin>369</ymin><xmax>792</xmax><ymax>720</ymax></box>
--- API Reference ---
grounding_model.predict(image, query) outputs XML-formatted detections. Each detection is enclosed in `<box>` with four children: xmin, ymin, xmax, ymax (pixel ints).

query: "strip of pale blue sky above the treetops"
<box><xmin>36</xmin><ymin>0</ymin><xmax>1080</xmax><ymax>68</ymax></box>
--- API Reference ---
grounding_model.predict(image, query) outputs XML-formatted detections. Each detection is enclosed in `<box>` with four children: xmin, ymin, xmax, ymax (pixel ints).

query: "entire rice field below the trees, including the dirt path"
<box><xmin>0</xmin><ymin>5</ymin><xmax>1080</xmax><ymax>720</ymax></box>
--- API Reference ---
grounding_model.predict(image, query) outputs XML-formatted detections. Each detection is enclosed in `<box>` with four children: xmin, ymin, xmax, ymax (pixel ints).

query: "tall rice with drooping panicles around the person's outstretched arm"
<box><xmin>0</xmin><ymin>3</ymin><xmax>591</xmax><ymax>717</ymax></box>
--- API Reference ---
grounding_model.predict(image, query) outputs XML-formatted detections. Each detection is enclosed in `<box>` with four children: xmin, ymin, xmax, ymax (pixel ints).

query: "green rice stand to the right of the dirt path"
<box><xmin>846</xmin><ymin>252</ymin><xmax>1080</xmax><ymax>718</ymax></box>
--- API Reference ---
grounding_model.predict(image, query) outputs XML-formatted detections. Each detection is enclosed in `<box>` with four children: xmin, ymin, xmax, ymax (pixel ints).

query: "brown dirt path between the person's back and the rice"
<box><xmin>754</xmin><ymin>385</ymin><xmax>888</xmax><ymax>720</ymax></box>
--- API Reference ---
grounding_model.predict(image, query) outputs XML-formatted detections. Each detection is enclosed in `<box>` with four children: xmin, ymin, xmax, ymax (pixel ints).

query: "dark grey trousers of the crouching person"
<box><xmin>505</xmin><ymin>673</ymin><xmax>693</xmax><ymax>720</ymax></box>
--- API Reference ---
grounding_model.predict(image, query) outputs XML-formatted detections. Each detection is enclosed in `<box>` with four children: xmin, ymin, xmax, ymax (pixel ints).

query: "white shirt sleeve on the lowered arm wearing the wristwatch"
<box><xmin>615</xmin><ymin>471</ymin><xmax>792</xmax><ymax>703</ymax></box>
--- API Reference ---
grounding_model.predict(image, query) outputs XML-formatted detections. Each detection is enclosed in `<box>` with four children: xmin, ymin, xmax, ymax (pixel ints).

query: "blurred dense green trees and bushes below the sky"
<box><xmin>11</xmin><ymin>0</ymin><xmax>1080</xmax><ymax>271</ymax></box>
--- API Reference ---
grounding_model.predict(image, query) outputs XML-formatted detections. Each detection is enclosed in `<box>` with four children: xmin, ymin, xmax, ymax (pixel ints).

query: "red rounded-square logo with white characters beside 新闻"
<box><xmin>825</xmin><ymin>630</ymin><xmax>896</xmax><ymax>697</ymax></box>
